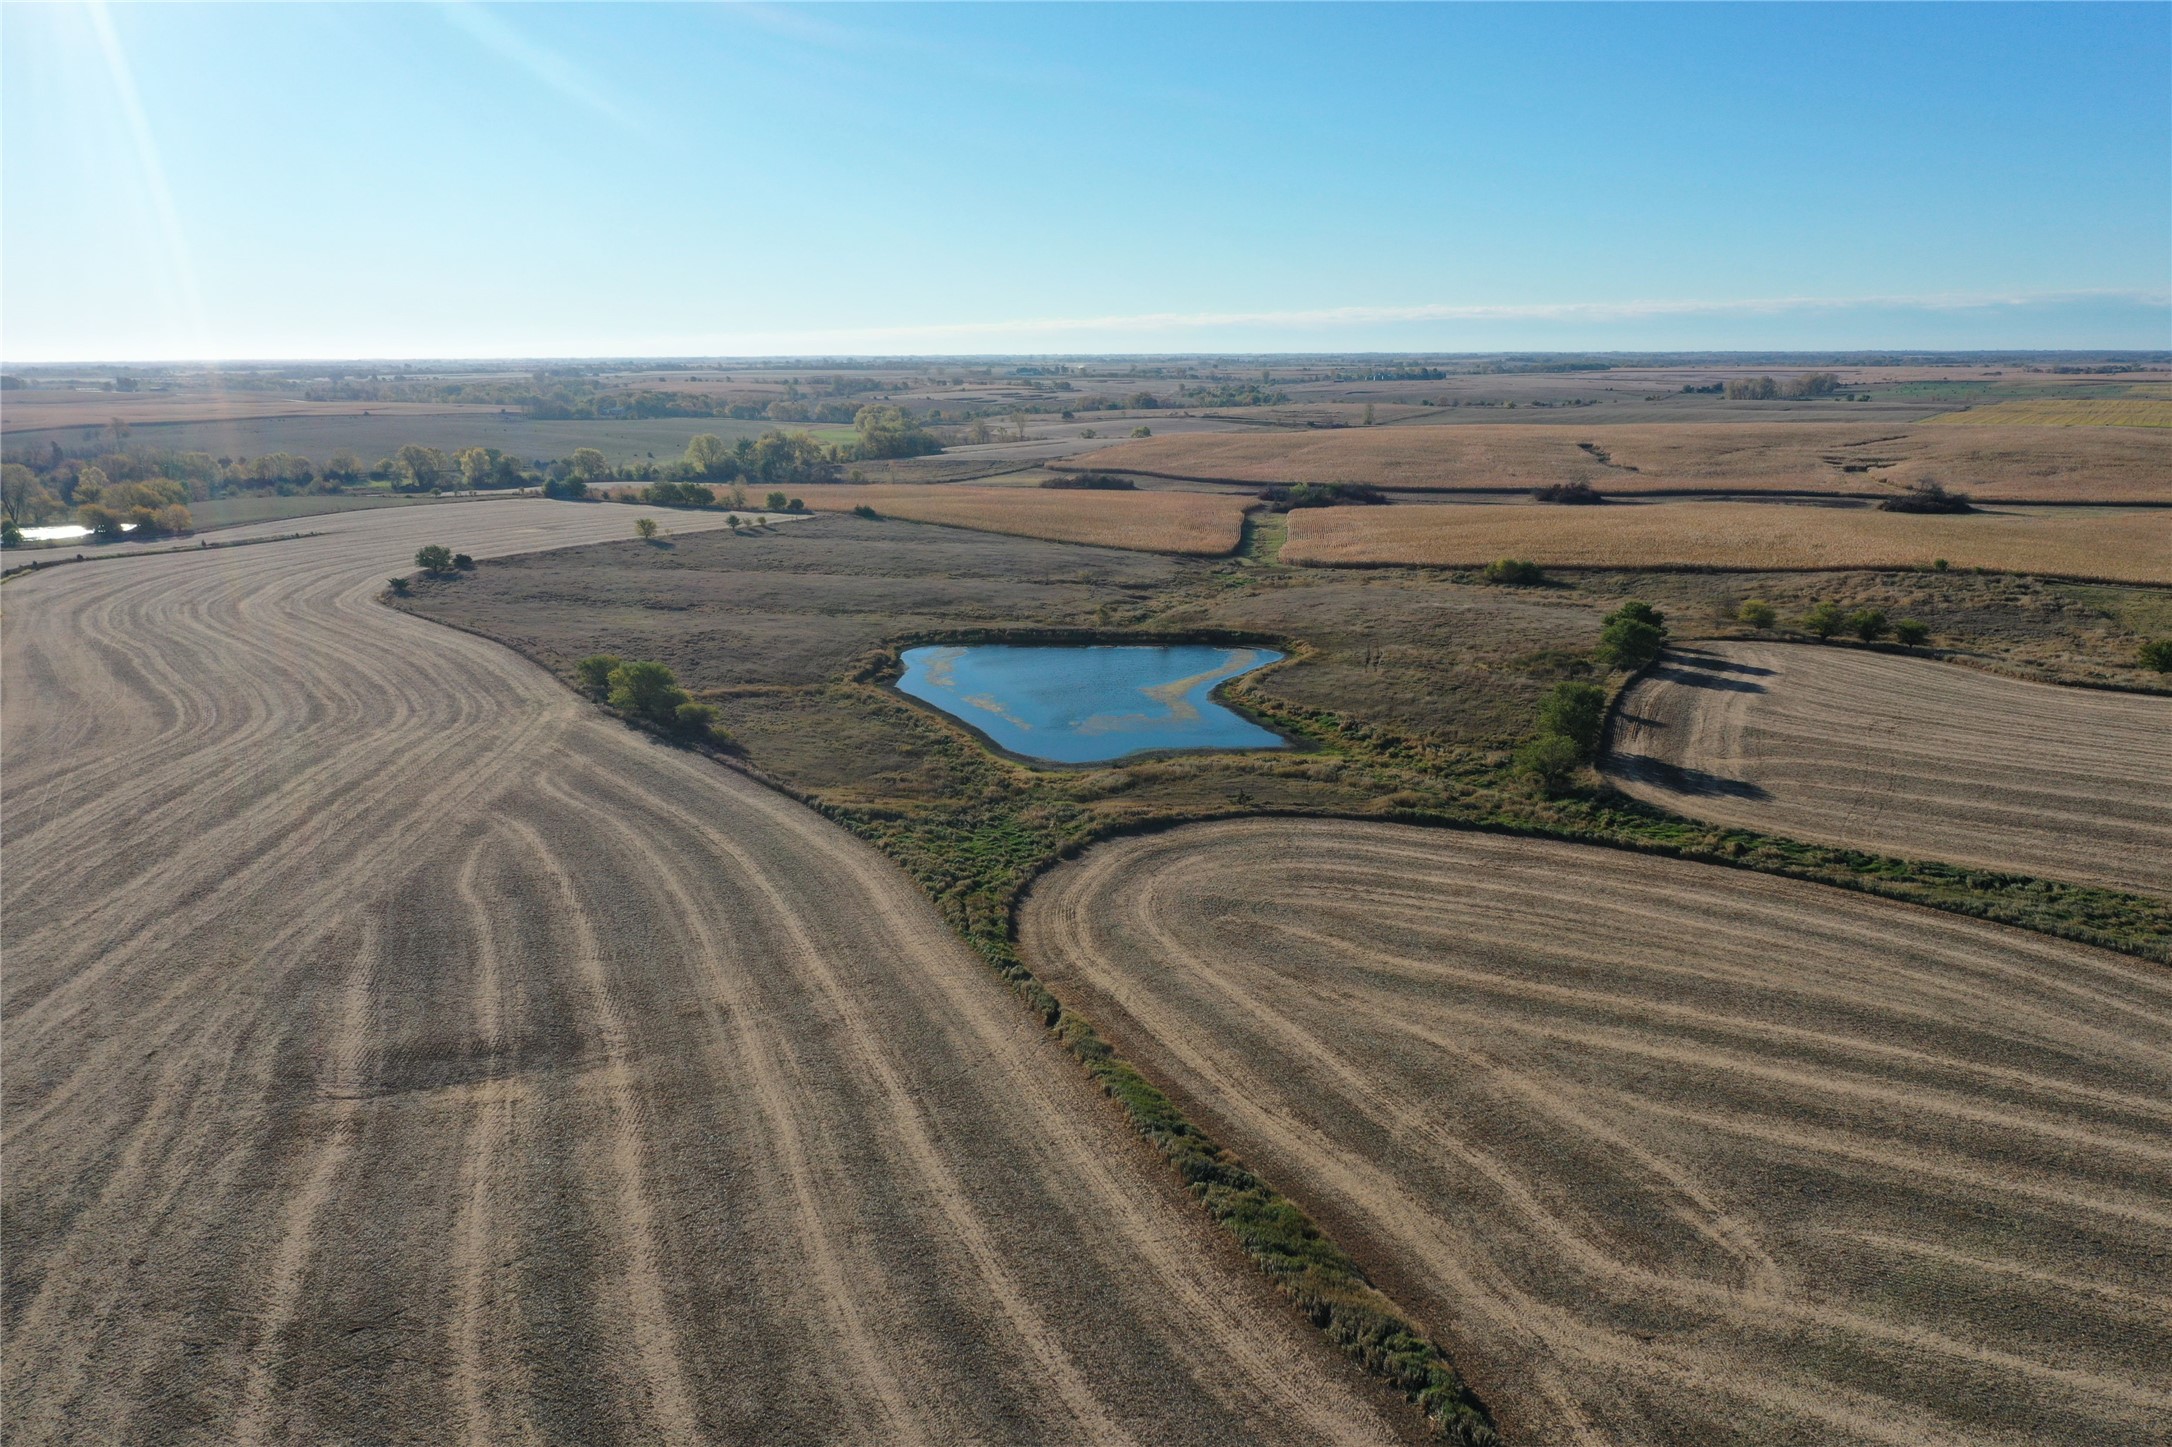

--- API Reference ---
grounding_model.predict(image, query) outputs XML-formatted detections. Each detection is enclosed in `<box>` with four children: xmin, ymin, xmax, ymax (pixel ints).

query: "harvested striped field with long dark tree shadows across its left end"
<box><xmin>1605</xmin><ymin>643</ymin><xmax>2172</xmax><ymax>895</ymax></box>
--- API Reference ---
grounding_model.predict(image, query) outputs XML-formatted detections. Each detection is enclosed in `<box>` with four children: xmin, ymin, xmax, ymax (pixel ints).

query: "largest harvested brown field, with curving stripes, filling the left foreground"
<box><xmin>0</xmin><ymin>502</ymin><xmax>1414</xmax><ymax>1447</ymax></box>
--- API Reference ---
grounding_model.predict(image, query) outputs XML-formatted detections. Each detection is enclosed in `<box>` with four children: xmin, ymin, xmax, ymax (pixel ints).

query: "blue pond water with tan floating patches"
<box><xmin>897</xmin><ymin>643</ymin><xmax>1284</xmax><ymax>763</ymax></box>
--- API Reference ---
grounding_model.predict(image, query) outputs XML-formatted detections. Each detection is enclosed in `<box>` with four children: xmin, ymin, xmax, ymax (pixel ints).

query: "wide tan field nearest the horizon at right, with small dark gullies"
<box><xmin>1072</xmin><ymin>421</ymin><xmax>2172</xmax><ymax>502</ymax></box>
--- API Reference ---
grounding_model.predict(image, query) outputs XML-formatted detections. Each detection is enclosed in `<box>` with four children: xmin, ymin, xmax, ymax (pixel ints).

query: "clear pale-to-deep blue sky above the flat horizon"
<box><xmin>0</xmin><ymin>2</ymin><xmax>2172</xmax><ymax>363</ymax></box>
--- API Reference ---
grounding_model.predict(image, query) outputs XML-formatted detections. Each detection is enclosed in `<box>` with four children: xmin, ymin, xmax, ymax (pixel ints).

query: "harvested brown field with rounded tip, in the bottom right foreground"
<box><xmin>1023</xmin><ymin>819</ymin><xmax>2172</xmax><ymax>1447</ymax></box>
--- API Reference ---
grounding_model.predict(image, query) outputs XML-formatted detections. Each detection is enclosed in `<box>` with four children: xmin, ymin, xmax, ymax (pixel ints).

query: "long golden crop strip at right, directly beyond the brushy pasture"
<box><xmin>1281</xmin><ymin>502</ymin><xmax>2172</xmax><ymax>582</ymax></box>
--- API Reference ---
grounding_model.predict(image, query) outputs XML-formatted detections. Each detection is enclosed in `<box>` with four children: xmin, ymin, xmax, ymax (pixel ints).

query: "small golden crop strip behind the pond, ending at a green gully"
<box><xmin>806</xmin><ymin>485</ymin><xmax>1249</xmax><ymax>554</ymax></box>
